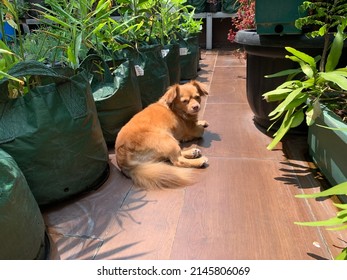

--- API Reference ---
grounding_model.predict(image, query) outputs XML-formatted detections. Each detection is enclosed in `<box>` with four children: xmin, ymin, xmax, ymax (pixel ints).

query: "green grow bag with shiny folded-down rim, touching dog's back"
<box><xmin>82</xmin><ymin>55</ymin><xmax>142</xmax><ymax>145</ymax></box>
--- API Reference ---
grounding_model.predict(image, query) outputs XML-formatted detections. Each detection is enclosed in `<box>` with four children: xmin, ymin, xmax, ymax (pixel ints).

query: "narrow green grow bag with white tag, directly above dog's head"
<box><xmin>162</xmin><ymin>43</ymin><xmax>181</xmax><ymax>85</ymax></box>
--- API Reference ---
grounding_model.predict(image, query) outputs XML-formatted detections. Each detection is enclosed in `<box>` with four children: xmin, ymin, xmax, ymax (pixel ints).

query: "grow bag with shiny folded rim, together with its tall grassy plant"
<box><xmin>33</xmin><ymin>0</ymin><xmax>142</xmax><ymax>145</ymax></box>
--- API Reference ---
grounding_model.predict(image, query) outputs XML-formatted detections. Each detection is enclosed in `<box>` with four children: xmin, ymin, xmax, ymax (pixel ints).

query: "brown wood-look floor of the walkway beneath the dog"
<box><xmin>43</xmin><ymin>50</ymin><xmax>347</xmax><ymax>260</ymax></box>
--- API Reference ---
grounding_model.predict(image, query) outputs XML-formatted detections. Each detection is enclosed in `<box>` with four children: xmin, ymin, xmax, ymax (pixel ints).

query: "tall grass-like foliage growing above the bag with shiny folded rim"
<box><xmin>35</xmin><ymin>0</ymin><xmax>128</xmax><ymax>69</ymax></box>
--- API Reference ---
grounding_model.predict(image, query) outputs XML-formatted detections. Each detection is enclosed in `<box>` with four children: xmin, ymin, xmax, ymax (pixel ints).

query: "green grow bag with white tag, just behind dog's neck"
<box><xmin>118</xmin><ymin>45</ymin><xmax>170</xmax><ymax>108</ymax></box>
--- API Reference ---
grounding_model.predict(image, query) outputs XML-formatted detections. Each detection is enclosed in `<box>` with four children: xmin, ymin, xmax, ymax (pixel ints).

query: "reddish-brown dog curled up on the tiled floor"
<box><xmin>115</xmin><ymin>80</ymin><xmax>208</xmax><ymax>189</ymax></box>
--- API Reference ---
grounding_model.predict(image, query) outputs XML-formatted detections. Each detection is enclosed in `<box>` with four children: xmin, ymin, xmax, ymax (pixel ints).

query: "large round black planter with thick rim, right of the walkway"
<box><xmin>235</xmin><ymin>30</ymin><xmax>346</xmax><ymax>133</ymax></box>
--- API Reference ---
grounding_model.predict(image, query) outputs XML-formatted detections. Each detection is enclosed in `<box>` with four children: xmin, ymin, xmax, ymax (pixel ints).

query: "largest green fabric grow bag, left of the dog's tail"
<box><xmin>0</xmin><ymin>62</ymin><xmax>109</xmax><ymax>206</ymax></box>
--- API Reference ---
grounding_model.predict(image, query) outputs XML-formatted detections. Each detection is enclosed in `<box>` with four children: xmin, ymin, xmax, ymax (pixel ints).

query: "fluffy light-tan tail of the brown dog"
<box><xmin>128</xmin><ymin>162</ymin><xmax>198</xmax><ymax>189</ymax></box>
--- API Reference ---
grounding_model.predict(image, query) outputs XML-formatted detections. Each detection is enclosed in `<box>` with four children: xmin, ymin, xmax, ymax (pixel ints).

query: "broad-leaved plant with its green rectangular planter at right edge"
<box><xmin>263</xmin><ymin>0</ymin><xmax>347</xmax><ymax>188</ymax></box>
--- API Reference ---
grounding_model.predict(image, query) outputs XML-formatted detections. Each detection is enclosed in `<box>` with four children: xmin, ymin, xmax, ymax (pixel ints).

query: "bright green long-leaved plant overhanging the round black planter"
<box><xmin>263</xmin><ymin>26</ymin><xmax>347</xmax><ymax>150</ymax></box>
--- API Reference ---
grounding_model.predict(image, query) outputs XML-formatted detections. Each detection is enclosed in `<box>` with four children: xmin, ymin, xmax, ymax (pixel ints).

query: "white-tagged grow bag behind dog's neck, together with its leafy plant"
<box><xmin>111</xmin><ymin>0</ymin><xmax>170</xmax><ymax>107</ymax></box>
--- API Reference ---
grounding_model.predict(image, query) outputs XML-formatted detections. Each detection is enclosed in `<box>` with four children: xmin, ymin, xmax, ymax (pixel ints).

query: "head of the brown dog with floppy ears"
<box><xmin>159</xmin><ymin>80</ymin><xmax>208</xmax><ymax>116</ymax></box>
